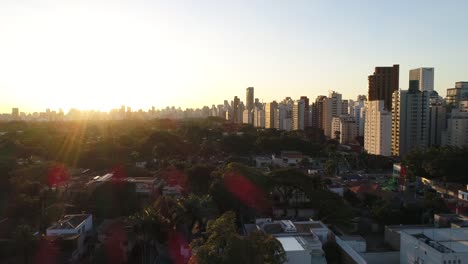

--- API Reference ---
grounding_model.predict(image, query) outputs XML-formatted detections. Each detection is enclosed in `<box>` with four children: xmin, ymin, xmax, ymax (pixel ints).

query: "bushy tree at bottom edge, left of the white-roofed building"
<box><xmin>189</xmin><ymin>212</ymin><xmax>286</xmax><ymax>264</ymax></box>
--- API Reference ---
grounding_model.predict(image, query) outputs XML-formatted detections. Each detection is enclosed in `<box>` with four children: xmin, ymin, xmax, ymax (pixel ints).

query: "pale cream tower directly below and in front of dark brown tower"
<box><xmin>364</xmin><ymin>100</ymin><xmax>392</xmax><ymax>156</ymax></box>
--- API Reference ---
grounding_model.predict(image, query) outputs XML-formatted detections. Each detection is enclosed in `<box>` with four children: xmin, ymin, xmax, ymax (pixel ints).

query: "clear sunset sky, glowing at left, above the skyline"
<box><xmin>0</xmin><ymin>0</ymin><xmax>468</xmax><ymax>112</ymax></box>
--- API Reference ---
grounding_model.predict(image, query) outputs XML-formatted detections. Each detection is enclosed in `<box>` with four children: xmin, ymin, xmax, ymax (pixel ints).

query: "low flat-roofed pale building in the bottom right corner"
<box><xmin>400</xmin><ymin>228</ymin><xmax>468</xmax><ymax>264</ymax></box>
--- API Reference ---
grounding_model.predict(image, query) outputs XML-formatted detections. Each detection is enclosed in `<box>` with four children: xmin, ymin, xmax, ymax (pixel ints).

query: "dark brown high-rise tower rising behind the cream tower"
<box><xmin>368</xmin><ymin>64</ymin><xmax>400</xmax><ymax>111</ymax></box>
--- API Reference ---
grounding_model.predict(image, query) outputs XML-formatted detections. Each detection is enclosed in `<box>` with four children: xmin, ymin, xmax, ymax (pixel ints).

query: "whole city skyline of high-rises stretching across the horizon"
<box><xmin>0</xmin><ymin>65</ymin><xmax>468</xmax><ymax>156</ymax></box>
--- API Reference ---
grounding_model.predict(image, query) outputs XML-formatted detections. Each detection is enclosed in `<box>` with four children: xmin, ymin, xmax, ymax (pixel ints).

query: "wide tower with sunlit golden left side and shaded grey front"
<box><xmin>392</xmin><ymin>86</ymin><xmax>429</xmax><ymax>157</ymax></box>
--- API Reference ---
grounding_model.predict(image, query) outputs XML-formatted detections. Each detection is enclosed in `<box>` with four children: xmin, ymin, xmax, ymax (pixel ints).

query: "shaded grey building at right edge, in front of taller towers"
<box><xmin>441</xmin><ymin>109</ymin><xmax>468</xmax><ymax>147</ymax></box>
